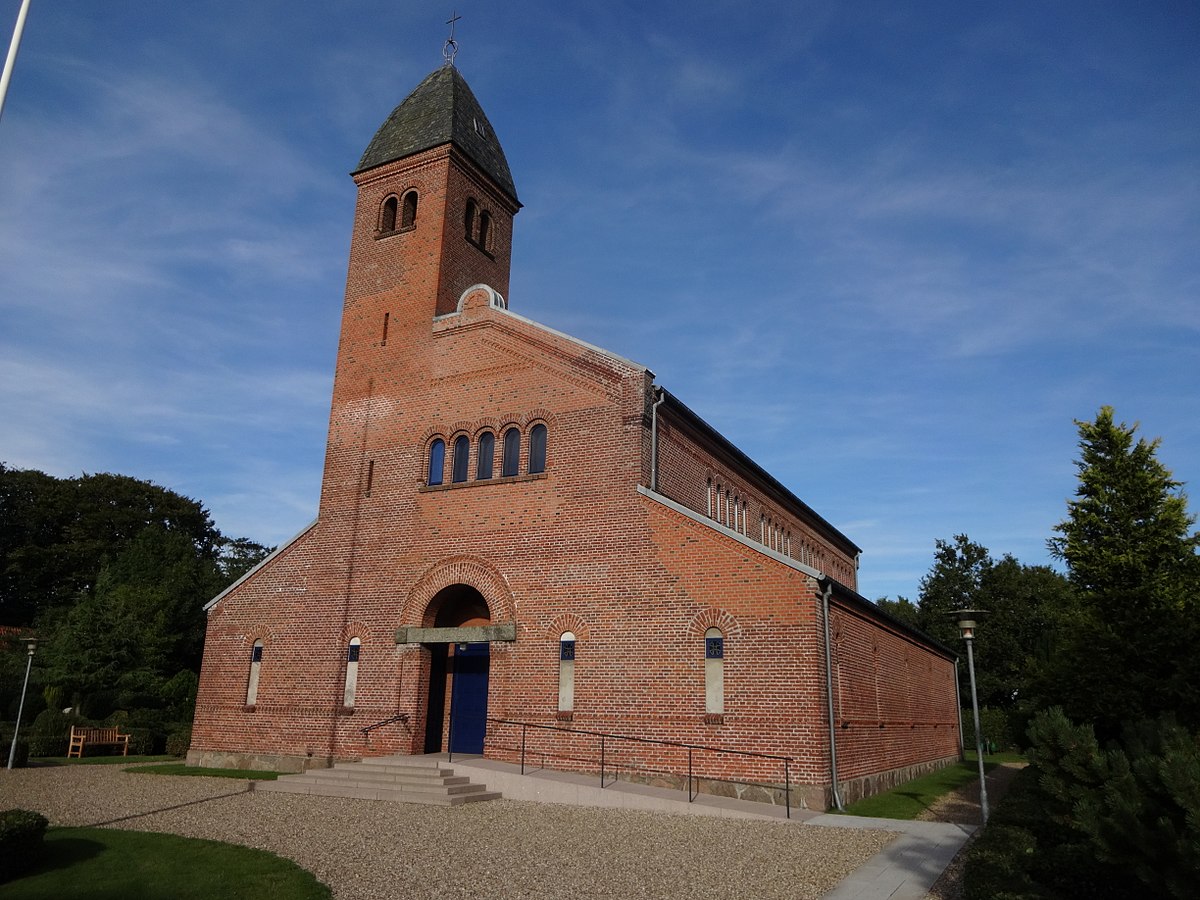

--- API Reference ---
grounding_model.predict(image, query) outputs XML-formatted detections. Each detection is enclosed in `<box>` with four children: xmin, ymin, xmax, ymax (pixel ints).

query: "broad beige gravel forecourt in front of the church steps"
<box><xmin>0</xmin><ymin>766</ymin><xmax>895</xmax><ymax>900</ymax></box>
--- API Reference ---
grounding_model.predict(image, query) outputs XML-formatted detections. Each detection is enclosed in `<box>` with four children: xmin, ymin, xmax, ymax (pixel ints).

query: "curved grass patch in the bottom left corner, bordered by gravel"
<box><xmin>0</xmin><ymin>828</ymin><xmax>331</xmax><ymax>900</ymax></box>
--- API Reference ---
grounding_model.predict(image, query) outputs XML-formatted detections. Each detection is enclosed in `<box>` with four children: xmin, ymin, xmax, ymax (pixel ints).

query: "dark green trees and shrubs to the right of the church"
<box><xmin>878</xmin><ymin>407</ymin><xmax>1200</xmax><ymax>900</ymax></box>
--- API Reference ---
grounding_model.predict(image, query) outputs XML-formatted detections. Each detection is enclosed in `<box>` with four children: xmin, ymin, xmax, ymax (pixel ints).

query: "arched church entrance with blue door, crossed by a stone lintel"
<box><xmin>424</xmin><ymin>584</ymin><xmax>492</xmax><ymax>754</ymax></box>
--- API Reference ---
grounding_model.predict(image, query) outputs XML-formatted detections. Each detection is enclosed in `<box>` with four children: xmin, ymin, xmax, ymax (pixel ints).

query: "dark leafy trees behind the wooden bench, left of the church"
<box><xmin>0</xmin><ymin>463</ymin><xmax>270</xmax><ymax>744</ymax></box>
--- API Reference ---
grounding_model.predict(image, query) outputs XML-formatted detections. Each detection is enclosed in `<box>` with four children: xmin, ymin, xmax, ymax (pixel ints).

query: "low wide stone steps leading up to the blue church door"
<box><xmin>254</xmin><ymin>756</ymin><xmax>500</xmax><ymax>806</ymax></box>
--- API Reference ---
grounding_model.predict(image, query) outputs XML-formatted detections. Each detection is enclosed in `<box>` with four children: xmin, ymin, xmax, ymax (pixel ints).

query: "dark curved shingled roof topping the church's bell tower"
<box><xmin>353</xmin><ymin>65</ymin><xmax>517</xmax><ymax>200</ymax></box>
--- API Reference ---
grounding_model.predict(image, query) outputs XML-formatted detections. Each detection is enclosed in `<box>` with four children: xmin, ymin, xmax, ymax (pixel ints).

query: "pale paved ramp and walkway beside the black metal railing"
<box><xmin>439</xmin><ymin>754</ymin><xmax>974</xmax><ymax>900</ymax></box>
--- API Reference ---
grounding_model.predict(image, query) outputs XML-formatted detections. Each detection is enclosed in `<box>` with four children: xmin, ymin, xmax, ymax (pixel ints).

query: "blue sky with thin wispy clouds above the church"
<box><xmin>0</xmin><ymin>0</ymin><xmax>1200</xmax><ymax>607</ymax></box>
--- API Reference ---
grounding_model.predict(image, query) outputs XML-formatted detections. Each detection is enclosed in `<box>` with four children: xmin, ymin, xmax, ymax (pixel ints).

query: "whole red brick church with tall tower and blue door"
<box><xmin>188</xmin><ymin>64</ymin><xmax>960</xmax><ymax>806</ymax></box>
